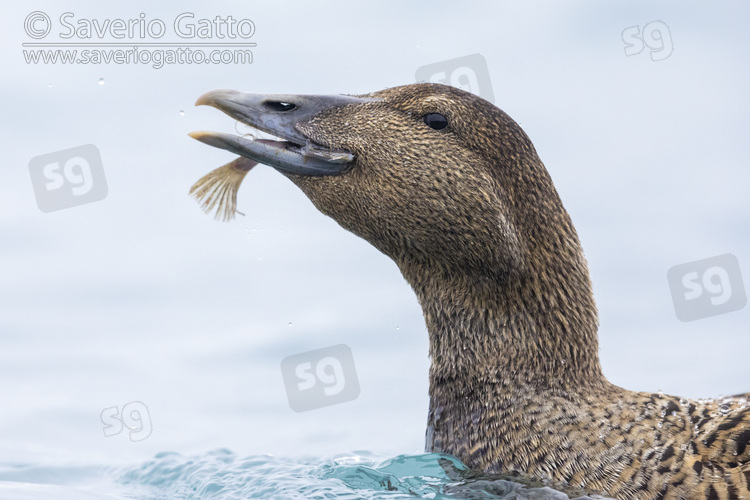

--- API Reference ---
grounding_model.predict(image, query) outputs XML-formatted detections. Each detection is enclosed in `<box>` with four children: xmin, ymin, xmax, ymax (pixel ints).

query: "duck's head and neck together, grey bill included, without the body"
<box><xmin>192</xmin><ymin>84</ymin><xmax>599</xmax><ymax>384</ymax></box>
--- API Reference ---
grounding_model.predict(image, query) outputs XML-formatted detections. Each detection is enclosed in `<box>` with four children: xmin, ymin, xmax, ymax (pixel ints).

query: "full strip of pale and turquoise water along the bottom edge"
<box><xmin>0</xmin><ymin>450</ymin><xmax>612</xmax><ymax>500</ymax></box>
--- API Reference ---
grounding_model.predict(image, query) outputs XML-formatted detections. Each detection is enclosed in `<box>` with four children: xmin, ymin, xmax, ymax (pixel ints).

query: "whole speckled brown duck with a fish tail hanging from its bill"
<box><xmin>191</xmin><ymin>84</ymin><xmax>750</xmax><ymax>499</ymax></box>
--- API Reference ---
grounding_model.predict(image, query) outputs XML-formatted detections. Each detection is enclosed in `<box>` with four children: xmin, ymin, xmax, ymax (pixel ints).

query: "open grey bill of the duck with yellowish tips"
<box><xmin>189</xmin><ymin>90</ymin><xmax>378</xmax><ymax>176</ymax></box>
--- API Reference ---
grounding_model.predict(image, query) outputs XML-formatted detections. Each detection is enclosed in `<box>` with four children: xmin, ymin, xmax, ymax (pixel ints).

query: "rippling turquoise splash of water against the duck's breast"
<box><xmin>121</xmin><ymin>450</ymin><xmax>612</xmax><ymax>499</ymax></box>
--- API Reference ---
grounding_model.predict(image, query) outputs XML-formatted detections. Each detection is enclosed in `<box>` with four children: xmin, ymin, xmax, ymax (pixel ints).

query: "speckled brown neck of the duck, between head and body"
<box><xmin>402</xmin><ymin>243</ymin><xmax>607</xmax><ymax>399</ymax></box>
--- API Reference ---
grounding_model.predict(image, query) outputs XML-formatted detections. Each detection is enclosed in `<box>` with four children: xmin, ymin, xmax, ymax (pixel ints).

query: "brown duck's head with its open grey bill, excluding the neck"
<box><xmin>192</xmin><ymin>84</ymin><xmax>556</xmax><ymax>282</ymax></box>
